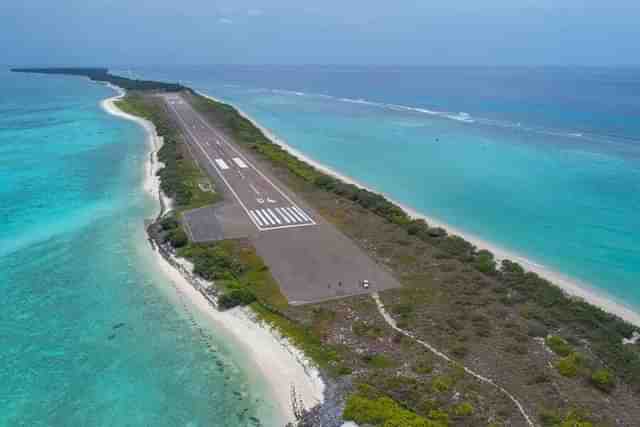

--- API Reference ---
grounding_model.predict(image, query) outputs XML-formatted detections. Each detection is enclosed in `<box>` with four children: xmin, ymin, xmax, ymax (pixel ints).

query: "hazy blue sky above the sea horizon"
<box><xmin>0</xmin><ymin>0</ymin><xmax>640</xmax><ymax>66</ymax></box>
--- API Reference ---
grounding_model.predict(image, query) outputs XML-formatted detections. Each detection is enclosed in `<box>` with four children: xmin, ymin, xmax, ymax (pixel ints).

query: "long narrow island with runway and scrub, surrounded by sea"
<box><xmin>14</xmin><ymin>68</ymin><xmax>640</xmax><ymax>427</ymax></box>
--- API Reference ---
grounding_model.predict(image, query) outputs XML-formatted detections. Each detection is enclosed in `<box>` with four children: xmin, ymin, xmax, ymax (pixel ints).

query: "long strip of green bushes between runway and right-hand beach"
<box><xmin>184</xmin><ymin>91</ymin><xmax>640</xmax><ymax>390</ymax></box>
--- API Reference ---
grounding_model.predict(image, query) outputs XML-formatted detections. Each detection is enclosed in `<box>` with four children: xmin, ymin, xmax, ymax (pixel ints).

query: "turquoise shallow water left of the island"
<box><xmin>0</xmin><ymin>70</ymin><xmax>279</xmax><ymax>427</ymax></box>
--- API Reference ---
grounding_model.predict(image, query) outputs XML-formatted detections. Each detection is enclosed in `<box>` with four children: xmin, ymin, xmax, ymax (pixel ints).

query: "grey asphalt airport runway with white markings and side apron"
<box><xmin>162</xmin><ymin>94</ymin><xmax>399</xmax><ymax>304</ymax></box>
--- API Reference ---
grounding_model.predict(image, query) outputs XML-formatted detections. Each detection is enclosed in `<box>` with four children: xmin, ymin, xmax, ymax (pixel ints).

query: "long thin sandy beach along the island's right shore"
<box><xmin>196</xmin><ymin>91</ymin><xmax>640</xmax><ymax>327</ymax></box>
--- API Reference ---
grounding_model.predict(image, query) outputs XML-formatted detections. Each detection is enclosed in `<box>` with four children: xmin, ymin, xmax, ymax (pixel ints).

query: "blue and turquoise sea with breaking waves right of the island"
<box><xmin>129</xmin><ymin>66</ymin><xmax>640</xmax><ymax>311</ymax></box>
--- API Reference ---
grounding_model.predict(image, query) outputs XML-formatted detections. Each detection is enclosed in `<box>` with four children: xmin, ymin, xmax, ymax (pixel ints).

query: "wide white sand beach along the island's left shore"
<box><xmin>101</xmin><ymin>85</ymin><xmax>326</xmax><ymax>422</ymax></box>
